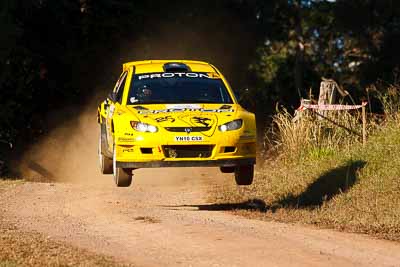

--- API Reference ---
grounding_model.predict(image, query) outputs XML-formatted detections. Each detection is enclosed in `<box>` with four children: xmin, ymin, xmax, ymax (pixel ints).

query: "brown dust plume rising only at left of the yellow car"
<box><xmin>20</xmin><ymin>102</ymin><xmax>104</xmax><ymax>183</ymax></box>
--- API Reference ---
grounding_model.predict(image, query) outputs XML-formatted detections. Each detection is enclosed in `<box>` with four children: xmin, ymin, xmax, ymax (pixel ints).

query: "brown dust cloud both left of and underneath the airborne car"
<box><xmin>19</xmin><ymin>100</ymin><xmax>227</xmax><ymax>187</ymax></box>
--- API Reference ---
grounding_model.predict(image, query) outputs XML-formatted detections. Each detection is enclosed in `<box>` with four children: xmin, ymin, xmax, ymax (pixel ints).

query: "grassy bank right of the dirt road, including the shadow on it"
<box><xmin>211</xmin><ymin>103</ymin><xmax>400</xmax><ymax>241</ymax></box>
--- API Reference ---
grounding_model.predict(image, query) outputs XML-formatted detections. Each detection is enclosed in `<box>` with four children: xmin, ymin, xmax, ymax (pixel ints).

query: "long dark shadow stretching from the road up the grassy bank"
<box><xmin>163</xmin><ymin>161</ymin><xmax>366</xmax><ymax>212</ymax></box>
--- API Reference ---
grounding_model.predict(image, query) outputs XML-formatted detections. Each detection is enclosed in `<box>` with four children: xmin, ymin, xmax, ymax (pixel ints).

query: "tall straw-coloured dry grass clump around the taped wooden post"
<box><xmin>266</xmin><ymin>107</ymin><xmax>366</xmax><ymax>160</ymax></box>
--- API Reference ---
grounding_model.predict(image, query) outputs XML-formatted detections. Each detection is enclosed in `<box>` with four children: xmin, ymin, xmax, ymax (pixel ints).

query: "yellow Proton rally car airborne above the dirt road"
<box><xmin>98</xmin><ymin>60</ymin><xmax>256</xmax><ymax>186</ymax></box>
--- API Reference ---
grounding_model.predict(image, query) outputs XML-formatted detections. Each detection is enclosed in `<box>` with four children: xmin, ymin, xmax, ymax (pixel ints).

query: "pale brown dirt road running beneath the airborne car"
<box><xmin>0</xmin><ymin>168</ymin><xmax>400</xmax><ymax>266</ymax></box>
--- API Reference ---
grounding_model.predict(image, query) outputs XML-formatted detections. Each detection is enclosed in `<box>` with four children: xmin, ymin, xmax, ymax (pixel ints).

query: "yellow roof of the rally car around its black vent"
<box><xmin>123</xmin><ymin>60</ymin><xmax>217</xmax><ymax>74</ymax></box>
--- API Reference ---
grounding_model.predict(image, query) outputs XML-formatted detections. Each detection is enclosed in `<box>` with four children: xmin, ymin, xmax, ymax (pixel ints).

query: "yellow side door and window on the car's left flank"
<box><xmin>106</xmin><ymin>71</ymin><xmax>128</xmax><ymax>151</ymax></box>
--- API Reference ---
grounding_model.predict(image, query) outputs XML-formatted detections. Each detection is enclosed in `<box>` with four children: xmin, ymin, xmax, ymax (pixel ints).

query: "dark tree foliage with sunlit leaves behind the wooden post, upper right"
<box><xmin>251</xmin><ymin>0</ymin><xmax>400</xmax><ymax>109</ymax></box>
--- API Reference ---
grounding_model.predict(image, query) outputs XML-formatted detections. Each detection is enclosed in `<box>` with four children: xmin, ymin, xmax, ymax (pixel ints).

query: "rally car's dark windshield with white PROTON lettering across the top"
<box><xmin>127</xmin><ymin>72</ymin><xmax>232</xmax><ymax>105</ymax></box>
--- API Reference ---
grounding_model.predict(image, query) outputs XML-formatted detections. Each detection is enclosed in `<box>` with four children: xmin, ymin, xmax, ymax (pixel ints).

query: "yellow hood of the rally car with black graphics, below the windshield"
<box><xmin>126</xmin><ymin>104</ymin><xmax>237</xmax><ymax>131</ymax></box>
